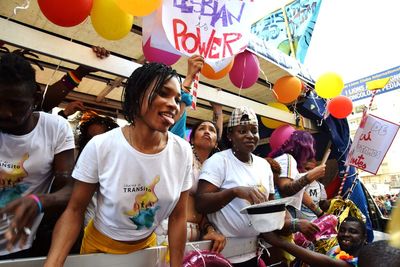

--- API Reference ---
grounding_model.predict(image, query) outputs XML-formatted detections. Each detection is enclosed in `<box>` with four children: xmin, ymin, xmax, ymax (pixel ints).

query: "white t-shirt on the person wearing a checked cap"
<box><xmin>199</xmin><ymin>149</ymin><xmax>275</xmax><ymax>240</ymax></box>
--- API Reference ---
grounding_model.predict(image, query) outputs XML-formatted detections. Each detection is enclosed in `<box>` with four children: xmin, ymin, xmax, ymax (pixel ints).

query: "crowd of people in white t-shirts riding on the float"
<box><xmin>0</xmin><ymin>49</ymin><xmax>398</xmax><ymax>267</ymax></box>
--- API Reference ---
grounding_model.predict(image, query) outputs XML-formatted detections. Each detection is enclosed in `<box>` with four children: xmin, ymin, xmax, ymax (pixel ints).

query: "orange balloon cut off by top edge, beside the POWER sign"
<box><xmin>115</xmin><ymin>0</ymin><xmax>162</xmax><ymax>17</ymax></box>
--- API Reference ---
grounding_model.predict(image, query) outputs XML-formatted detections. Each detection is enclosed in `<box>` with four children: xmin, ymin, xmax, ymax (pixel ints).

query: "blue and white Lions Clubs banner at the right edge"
<box><xmin>342</xmin><ymin>66</ymin><xmax>400</xmax><ymax>101</ymax></box>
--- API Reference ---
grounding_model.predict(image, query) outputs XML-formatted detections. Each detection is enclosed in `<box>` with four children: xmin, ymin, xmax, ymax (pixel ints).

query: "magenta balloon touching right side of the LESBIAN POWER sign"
<box><xmin>229</xmin><ymin>50</ymin><xmax>260</xmax><ymax>89</ymax></box>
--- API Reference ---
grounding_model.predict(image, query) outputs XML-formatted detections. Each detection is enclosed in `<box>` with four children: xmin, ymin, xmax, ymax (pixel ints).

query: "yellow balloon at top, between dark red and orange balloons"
<box><xmin>90</xmin><ymin>0</ymin><xmax>133</xmax><ymax>40</ymax></box>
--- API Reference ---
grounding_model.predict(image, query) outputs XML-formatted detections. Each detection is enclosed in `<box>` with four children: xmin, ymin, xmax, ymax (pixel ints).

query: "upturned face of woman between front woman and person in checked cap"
<box><xmin>191</xmin><ymin>121</ymin><xmax>217</xmax><ymax>152</ymax></box>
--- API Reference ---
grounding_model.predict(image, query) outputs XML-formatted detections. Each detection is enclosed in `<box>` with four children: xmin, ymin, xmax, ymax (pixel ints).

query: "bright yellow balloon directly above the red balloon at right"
<box><xmin>315</xmin><ymin>72</ymin><xmax>344</xmax><ymax>98</ymax></box>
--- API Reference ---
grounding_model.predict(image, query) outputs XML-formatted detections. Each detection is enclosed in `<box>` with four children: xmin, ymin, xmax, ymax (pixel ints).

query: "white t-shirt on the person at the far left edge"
<box><xmin>0</xmin><ymin>112</ymin><xmax>75</xmax><ymax>255</ymax></box>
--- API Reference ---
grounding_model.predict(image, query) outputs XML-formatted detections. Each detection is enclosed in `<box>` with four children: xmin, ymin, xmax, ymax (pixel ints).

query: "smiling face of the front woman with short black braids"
<box><xmin>136</xmin><ymin>77</ymin><xmax>181</xmax><ymax>132</ymax></box>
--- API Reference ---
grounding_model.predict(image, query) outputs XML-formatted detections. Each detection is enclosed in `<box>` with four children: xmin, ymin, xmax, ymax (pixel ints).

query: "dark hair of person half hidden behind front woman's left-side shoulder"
<box><xmin>78</xmin><ymin>116</ymin><xmax>119</xmax><ymax>151</ymax></box>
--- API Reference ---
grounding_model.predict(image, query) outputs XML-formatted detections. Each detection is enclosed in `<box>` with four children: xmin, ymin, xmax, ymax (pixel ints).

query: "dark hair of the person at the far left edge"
<box><xmin>0</xmin><ymin>53</ymin><xmax>37</xmax><ymax>96</ymax></box>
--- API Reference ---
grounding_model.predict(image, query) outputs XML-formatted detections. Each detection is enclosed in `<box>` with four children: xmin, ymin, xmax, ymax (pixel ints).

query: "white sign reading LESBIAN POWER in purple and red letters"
<box><xmin>162</xmin><ymin>0</ymin><xmax>261</xmax><ymax>66</ymax></box>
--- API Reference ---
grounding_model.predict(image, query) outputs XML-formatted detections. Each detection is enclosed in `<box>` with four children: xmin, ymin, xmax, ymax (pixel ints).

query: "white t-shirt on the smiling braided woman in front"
<box><xmin>72</xmin><ymin>128</ymin><xmax>192</xmax><ymax>241</ymax></box>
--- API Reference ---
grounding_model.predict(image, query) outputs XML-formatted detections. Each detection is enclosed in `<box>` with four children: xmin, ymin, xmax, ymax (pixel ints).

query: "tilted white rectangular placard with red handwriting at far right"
<box><xmin>345</xmin><ymin>114</ymin><xmax>399</xmax><ymax>174</ymax></box>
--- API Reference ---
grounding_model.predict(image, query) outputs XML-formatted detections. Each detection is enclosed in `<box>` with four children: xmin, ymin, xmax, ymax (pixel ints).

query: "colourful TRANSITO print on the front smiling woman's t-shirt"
<box><xmin>124</xmin><ymin>175</ymin><xmax>160</xmax><ymax>230</ymax></box>
